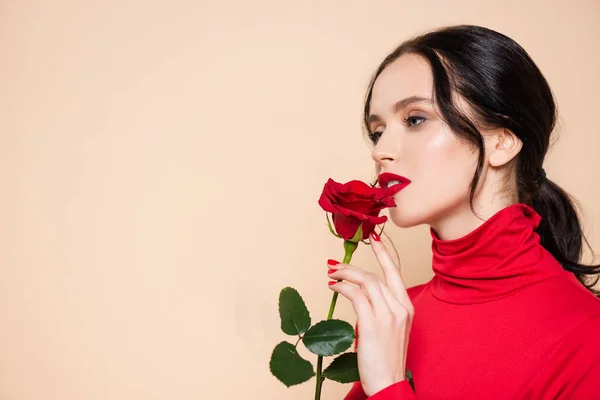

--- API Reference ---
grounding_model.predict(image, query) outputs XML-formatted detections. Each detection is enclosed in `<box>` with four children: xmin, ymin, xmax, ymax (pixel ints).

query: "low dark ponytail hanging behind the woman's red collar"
<box><xmin>533</xmin><ymin>177</ymin><xmax>600</xmax><ymax>296</ymax></box>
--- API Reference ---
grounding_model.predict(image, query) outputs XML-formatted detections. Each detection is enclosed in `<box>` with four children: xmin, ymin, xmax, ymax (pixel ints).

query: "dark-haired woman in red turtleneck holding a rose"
<box><xmin>328</xmin><ymin>26</ymin><xmax>600</xmax><ymax>400</ymax></box>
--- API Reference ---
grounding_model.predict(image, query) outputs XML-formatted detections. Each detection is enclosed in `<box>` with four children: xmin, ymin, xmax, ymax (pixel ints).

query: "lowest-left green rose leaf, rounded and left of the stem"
<box><xmin>269</xmin><ymin>342</ymin><xmax>315</xmax><ymax>387</ymax></box>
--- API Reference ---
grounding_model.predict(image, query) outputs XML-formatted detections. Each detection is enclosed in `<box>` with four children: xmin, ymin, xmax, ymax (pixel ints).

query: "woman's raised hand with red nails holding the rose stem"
<box><xmin>328</xmin><ymin>232</ymin><xmax>414</xmax><ymax>396</ymax></box>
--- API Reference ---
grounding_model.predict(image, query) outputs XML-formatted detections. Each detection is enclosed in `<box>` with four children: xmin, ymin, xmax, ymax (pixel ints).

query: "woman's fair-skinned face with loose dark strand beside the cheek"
<box><xmin>369</xmin><ymin>54</ymin><xmax>477</xmax><ymax>228</ymax></box>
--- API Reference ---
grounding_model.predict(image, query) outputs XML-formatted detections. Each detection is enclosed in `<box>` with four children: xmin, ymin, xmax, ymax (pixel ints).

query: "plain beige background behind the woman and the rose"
<box><xmin>0</xmin><ymin>0</ymin><xmax>600</xmax><ymax>400</ymax></box>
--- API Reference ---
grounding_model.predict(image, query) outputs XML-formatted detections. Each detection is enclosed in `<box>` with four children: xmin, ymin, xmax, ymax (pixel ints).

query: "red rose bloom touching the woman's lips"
<box><xmin>319</xmin><ymin>179</ymin><xmax>396</xmax><ymax>240</ymax></box>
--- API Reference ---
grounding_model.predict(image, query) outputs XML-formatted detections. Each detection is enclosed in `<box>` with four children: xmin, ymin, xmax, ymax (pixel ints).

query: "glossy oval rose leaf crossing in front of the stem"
<box><xmin>302</xmin><ymin>319</ymin><xmax>356</xmax><ymax>356</ymax></box>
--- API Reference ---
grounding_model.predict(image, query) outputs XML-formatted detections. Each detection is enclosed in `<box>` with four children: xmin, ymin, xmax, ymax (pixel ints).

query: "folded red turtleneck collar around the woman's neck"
<box><xmin>430</xmin><ymin>203</ymin><xmax>564</xmax><ymax>304</ymax></box>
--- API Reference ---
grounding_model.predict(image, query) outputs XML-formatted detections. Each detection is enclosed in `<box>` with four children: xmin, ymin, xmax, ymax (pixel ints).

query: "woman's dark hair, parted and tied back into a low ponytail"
<box><xmin>363</xmin><ymin>25</ymin><xmax>600</xmax><ymax>296</ymax></box>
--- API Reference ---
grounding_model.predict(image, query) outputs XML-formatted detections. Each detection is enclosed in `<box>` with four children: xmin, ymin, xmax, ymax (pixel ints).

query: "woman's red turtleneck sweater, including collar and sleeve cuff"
<box><xmin>345</xmin><ymin>204</ymin><xmax>600</xmax><ymax>400</ymax></box>
